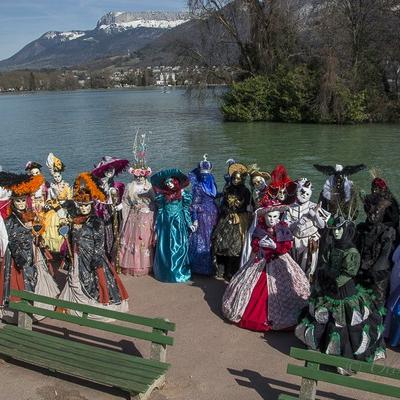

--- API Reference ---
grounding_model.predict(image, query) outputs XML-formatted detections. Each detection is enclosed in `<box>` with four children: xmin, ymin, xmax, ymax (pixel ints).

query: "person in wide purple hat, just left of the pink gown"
<box><xmin>92</xmin><ymin>156</ymin><xmax>129</xmax><ymax>268</ymax></box>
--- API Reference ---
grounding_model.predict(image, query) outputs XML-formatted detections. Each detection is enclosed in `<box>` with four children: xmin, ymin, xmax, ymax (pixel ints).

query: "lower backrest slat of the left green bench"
<box><xmin>9</xmin><ymin>301</ymin><xmax>174</xmax><ymax>345</ymax></box>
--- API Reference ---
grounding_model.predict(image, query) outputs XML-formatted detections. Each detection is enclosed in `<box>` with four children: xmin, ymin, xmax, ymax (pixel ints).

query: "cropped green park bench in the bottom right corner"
<box><xmin>279</xmin><ymin>347</ymin><xmax>400</xmax><ymax>400</ymax></box>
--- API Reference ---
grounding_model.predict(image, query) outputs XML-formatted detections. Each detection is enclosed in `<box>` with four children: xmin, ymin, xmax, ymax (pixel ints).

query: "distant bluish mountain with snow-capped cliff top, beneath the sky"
<box><xmin>0</xmin><ymin>12</ymin><xmax>189</xmax><ymax>70</ymax></box>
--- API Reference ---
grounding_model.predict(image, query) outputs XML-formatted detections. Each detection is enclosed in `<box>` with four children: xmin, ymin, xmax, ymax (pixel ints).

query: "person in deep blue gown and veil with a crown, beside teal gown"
<box><xmin>189</xmin><ymin>154</ymin><xmax>218</xmax><ymax>276</ymax></box>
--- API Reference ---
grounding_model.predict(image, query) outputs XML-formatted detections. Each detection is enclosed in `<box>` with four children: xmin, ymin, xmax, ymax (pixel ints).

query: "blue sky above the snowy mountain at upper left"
<box><xmin>0</xmin><ymin>0</ymin><xmax>187</xmax><ymax>60</ymax></box>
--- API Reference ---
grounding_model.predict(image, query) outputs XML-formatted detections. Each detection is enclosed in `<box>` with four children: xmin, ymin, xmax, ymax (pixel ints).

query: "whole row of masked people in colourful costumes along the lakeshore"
<box><xmin>0</xmin><ymin>134</ymin><xmax>400</xmax><ymax>374</ymax></box>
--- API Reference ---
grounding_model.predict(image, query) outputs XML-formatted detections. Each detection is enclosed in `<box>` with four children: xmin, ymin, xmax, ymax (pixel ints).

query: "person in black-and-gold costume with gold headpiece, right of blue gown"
<box><xmin>212</xmin><ymin>163</ymin><xmax>251</xmax><ymax>280</ymax></box>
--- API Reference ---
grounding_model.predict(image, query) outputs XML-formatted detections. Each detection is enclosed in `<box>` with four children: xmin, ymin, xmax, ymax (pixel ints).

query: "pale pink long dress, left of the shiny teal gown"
<box><xmin>119</xmin><ymin>182</ymin><xmax>154</xmax><ymax>276</ymax></box>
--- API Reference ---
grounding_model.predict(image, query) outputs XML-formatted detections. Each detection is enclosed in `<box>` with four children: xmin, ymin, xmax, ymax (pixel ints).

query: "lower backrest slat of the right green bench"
<box><xmin>287</xmin><ymin>364</ymin><xmax>400</xmax><ymax>398</ymax></box>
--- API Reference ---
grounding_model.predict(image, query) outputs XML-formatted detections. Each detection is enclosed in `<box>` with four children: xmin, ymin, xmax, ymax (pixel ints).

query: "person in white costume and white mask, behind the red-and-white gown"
<box><xmin>284</xmin><ymin>178</ymin><xmax>330</xmax><ymax>281</ymax></box>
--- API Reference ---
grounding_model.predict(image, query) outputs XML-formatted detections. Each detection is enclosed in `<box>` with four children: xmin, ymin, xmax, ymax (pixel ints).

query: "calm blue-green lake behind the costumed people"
<box><xmin>0</xmin><ymin>88</ymin><xmax>400</xmax><ymax>205</ymax></box>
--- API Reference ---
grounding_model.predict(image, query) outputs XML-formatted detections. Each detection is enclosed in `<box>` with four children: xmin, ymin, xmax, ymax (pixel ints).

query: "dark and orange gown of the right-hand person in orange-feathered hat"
<box><xmin>60</xmin><ymin>215</ymin><xmax>128</xmax><ymax>315</ymax></box>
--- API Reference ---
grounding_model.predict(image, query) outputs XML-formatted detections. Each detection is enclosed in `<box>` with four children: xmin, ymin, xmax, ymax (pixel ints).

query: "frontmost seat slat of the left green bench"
<box><xmin>0</xmin><ymin>346</ymin><xmax>148</xmax><ymax>393</ymax></box>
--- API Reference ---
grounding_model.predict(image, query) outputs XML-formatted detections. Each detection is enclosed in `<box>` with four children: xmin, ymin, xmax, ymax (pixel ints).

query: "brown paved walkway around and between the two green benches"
<box><xmin>0</xmin><ymin>276</ymin><xmax>400</xmax><ymax>400</ymax></box>
